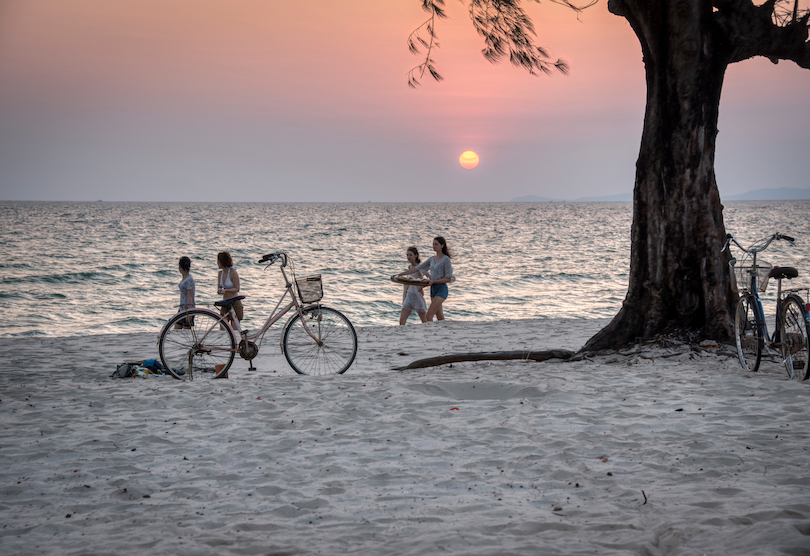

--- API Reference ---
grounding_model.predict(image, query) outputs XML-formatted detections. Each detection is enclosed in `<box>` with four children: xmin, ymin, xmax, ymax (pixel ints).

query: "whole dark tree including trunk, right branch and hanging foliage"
<box><xmin>409</xmin><ymin>0</ymin><xmax>810</xmax><ymax>351</ymax></box>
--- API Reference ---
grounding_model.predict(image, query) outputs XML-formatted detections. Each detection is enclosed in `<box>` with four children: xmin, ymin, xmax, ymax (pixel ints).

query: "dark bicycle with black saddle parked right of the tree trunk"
<box><xmin>721</xmin><ymin>233</ymin><xmax>810</xmax><ymax>380</ymax></box>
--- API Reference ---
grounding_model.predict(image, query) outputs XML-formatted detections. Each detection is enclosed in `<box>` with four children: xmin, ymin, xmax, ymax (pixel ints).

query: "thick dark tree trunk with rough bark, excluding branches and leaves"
<box><xmin>583</xmin><ymin>0</ymin><xmax>734</xmax><ymax>351</ymax></box>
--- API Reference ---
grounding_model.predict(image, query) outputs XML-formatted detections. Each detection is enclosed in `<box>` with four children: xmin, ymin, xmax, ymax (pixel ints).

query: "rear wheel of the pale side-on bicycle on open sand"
<box><xmin>158</xmin><ymin>309</ymin><xmax>236</xmax><ymax>380</ymax></box>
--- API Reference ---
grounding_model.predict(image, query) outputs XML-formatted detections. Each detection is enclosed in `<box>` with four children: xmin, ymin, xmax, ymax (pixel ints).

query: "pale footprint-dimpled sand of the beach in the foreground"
<box><xmin>0</xmin><ymin>319</ymin><xmax>810</xmax><ymax>556</ymax></box>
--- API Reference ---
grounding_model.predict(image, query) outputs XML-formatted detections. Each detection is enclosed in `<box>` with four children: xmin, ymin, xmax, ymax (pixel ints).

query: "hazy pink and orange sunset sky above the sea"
<box><xmin>0</xmin><ymin>0</ymin><xmax>810</xmax><ymax>202</ymax></box>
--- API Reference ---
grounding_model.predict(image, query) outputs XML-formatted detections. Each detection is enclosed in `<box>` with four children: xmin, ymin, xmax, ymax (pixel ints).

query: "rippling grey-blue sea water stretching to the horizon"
<box><xmin>0</xmin><ymin>201</ymin><xmax>810</xmax><ymax>337</ymax></box>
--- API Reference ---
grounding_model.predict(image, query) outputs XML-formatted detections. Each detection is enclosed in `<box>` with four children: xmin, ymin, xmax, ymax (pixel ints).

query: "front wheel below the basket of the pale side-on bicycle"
<box><xmin>283</xmin><ymin>307</ymin><xmax>357</xmax><ymax>375</ymax></box>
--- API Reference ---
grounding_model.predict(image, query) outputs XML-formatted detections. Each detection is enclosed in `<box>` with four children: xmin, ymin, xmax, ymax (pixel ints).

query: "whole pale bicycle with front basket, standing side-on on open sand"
<box><xmin>158</xmin><ymin>252</ymin><xmax>357</xmax><ymax>380</ymax></box>
